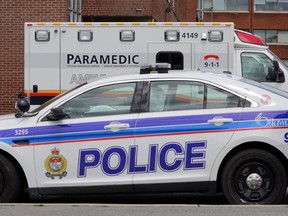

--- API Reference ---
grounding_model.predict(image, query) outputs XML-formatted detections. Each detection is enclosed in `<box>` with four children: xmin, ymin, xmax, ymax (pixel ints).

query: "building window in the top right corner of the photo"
<box><xmin>254</xmin><ymin>0</ymin><xmax>288</xmax><ymax>11</ymax></box>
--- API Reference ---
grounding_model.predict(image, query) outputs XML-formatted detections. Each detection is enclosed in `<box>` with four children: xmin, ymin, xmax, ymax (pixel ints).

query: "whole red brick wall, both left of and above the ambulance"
<box><xmin>0</xmin><ymin>0</ymin><xmax>196</xmax><ymax>115</ymax></box>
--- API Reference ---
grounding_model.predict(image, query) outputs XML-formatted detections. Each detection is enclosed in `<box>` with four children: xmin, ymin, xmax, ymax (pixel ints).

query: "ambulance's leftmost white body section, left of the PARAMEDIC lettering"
<box><xmin>24</xmin><ymin>23</ymin><xmax>60</xmax><ymax>106</ymax></box>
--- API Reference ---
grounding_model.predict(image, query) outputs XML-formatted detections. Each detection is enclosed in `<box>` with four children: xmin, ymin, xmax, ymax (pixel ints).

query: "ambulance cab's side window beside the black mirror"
<box><xmin>241</xmin><ymin>52</ymin><xmax>273</xmax><ymax>82</ymax></box>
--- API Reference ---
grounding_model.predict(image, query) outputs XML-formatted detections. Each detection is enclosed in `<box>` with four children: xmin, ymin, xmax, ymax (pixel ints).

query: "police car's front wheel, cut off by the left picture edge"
<box><xmin>0</xmin><ymin>155</ymin><xmax>22</xmax><ymax>203</ymax></box>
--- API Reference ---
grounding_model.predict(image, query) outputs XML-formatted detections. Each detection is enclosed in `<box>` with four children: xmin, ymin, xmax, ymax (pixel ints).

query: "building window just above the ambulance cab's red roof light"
<box><xmin>254</xmin><ymin>30</ymin><xmax>288</xmax><ymax>43</ymax></box>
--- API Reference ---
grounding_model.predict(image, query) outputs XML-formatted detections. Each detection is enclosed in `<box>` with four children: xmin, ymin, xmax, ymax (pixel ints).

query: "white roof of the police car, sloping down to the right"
<box><xmin>85</xmin><ymin>70</ymin><xmax>288</xmax><ymax>106</ymax></box>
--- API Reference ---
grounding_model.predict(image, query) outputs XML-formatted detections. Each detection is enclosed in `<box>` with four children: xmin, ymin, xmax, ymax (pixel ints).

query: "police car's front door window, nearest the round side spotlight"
<box><xmin>63</xmin><ymin>83</ymin><xmax>136</xmax><ymax>118</ymax></box>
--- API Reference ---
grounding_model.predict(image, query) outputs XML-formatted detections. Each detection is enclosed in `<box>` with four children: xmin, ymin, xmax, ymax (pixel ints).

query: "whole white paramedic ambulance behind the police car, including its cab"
<box><xmin>24</xmin><ymin>22</ymin><xmax>288</xmax><ymax>108</ymax></box>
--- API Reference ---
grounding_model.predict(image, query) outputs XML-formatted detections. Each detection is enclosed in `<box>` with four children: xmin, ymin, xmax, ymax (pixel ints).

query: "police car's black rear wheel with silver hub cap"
<box><xmin>221</xmin><ymin>149</ymin><xmax>287</xmax><ymax>204</ymax></box>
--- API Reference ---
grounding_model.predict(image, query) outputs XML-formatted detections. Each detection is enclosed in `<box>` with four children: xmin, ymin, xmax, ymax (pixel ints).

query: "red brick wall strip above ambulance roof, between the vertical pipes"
<box><xmin>82</xmin><ymin>0</ymin><xmax>192</xmax><ymax>22</ymax></box>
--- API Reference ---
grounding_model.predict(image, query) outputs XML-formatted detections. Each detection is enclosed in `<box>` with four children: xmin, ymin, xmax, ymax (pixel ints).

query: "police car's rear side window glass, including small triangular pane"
<box><xmin>148</xmin><ymin>81</ymin><xmax>245</xmax><ymax>112</ymax></box>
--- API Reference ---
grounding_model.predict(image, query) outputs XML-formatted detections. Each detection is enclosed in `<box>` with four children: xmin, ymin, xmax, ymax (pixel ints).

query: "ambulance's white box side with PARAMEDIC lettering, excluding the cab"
<box><xmin>25</xmin><ymin>23</ymin><xmax>234</xmax><ymax>105</ymax></box>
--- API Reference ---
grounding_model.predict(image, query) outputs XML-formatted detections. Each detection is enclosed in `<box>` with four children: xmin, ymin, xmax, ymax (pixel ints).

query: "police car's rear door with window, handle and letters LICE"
<box><xmin>131</xmin><ymin>80</ymin><xmax>245</xmax><ymax>192</ymax></box>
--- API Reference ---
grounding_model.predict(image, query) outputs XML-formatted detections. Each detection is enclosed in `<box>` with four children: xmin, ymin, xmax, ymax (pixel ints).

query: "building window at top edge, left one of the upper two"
<box><xmin>204</xmin><ymin>0</ymin><xmax>249</xmax><ymax>11</ymax></box>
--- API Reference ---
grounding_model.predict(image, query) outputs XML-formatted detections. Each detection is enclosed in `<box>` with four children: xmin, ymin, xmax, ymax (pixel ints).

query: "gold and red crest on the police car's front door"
<box><xmin>44</xmin><ymin>147</ymin><xmax>67</xmax><ymax>179</ymax></box>
